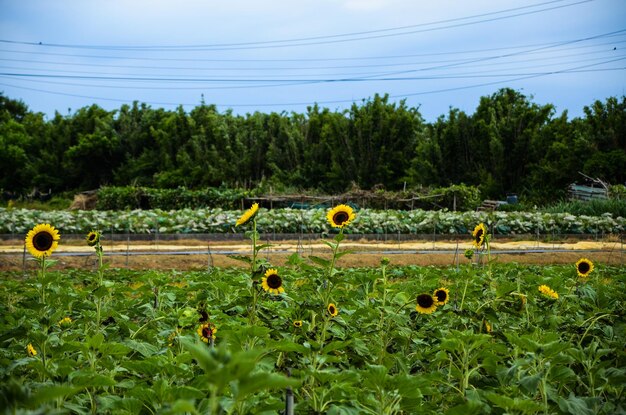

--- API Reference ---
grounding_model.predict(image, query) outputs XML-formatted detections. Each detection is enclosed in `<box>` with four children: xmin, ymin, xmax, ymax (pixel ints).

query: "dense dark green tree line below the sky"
<box><xmin>0</xmin><ymin>88</ymin><xmax>626</xmax><ymax>202</ymax></box>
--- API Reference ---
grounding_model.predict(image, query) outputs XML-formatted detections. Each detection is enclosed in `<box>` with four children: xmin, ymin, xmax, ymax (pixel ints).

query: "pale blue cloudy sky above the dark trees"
<box><xmin>0</xmin><ymin>0</ymin><xmax>626</xmax><ymax>122</ymax></box>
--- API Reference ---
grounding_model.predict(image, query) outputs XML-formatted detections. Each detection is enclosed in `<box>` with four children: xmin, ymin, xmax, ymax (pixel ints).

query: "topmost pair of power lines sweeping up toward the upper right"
<box><xmin>0</xmin><ymin>0</ymin><xmax>595</xmax><ymax>52</ymax></box>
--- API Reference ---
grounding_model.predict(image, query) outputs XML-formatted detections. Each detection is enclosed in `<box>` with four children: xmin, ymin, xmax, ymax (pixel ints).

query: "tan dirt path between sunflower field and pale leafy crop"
<box><xmin>0</xmin><ymin>240</ymin><xmax>626</xmax><ymax>271</ymax></box>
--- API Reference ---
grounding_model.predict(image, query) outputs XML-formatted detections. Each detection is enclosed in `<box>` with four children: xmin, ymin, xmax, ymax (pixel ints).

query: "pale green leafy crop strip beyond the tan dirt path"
<box><xmin>0</xmin><ymin>208</ymin><xmax>626</xmax><ymax>235</ymax></box>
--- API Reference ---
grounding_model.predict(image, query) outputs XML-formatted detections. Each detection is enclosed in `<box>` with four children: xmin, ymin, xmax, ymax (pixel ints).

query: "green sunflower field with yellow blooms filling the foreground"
<box><xmin>0</xmin><ymin>205</ymin><xmax>626</xmax><ymax>415</ymax></box>
